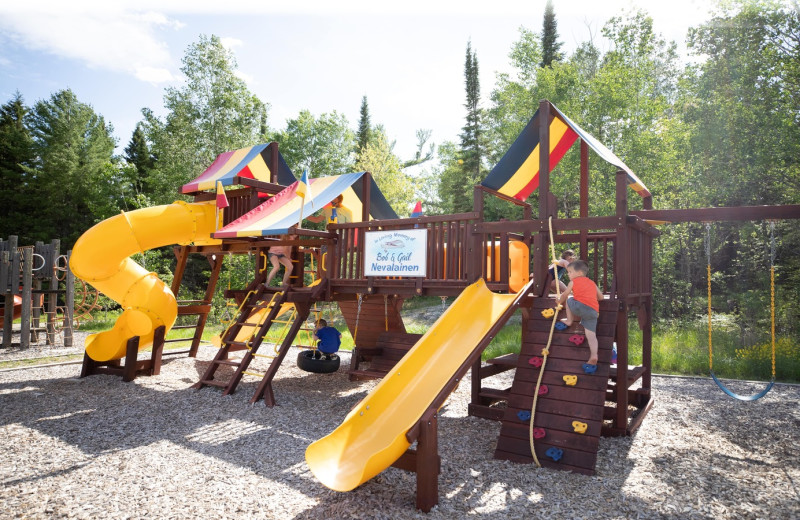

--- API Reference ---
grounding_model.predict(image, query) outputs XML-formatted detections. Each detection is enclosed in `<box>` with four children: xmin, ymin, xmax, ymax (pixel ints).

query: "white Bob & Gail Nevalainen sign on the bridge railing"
<box><xmin>364</xmin><ymin>229</ymin><xmax>428</xmax><ymax>276</ymax></box>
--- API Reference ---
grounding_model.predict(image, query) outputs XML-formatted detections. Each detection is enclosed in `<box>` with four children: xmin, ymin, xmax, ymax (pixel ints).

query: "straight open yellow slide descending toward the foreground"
<box><xmin>306</xmin><ymin>280</ymin><xmax>524</xmax><ymax>491</ymax></box>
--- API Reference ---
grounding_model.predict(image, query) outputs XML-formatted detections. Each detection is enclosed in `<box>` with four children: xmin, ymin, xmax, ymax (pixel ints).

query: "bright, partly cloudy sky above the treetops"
<box><xmin>0</xmin><ymin>0</ymin><xmax>710</xmax><ymax>167</ymax></box>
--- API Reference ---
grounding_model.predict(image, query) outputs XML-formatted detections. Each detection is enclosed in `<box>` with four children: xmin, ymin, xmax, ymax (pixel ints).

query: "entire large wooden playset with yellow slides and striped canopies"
<box><xmin>71</xmin><ymin>101</ymin><xmax>800</xmax><ymax>511</ymax></box>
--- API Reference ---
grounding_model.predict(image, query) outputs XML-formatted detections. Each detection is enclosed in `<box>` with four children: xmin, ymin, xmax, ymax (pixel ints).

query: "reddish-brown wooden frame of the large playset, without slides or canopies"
<box><xmin>72</xmin><ymin>100</ymin><xmax>800</xmax><ymax>511</ymax></box>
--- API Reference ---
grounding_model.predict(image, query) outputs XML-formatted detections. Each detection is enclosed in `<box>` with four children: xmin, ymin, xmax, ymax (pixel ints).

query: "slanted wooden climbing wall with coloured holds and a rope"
<box><xmin>494</xmin><ymin>298</ymin><xmax>619</xmax><ymax>475</ymax></box>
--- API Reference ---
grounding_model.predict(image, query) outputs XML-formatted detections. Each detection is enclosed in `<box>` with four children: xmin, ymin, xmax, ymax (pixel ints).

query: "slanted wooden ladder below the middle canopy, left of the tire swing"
<box><xmin>193</xmin><ymin>277</ymin><xmax>292</xmax><ymax>395</ymax></box>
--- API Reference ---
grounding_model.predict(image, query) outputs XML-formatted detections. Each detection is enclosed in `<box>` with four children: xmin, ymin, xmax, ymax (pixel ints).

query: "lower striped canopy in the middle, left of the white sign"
<box><xmin>214</xmin><ymin>172</ymin><xmax>397</xmax><ymax>238</ymax></box>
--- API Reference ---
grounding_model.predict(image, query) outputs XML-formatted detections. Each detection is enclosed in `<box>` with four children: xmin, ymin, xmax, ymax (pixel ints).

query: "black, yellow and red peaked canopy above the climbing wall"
<box><xmin>481</xmin><ymin>103</ymin><xmax>650</xmax><ymax>200</ymax></box>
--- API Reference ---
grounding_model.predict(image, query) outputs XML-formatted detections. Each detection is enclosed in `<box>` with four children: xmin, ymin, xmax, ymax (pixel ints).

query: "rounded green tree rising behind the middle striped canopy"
<box><xmin>275</xmin><ymin>110</ymin><xmax>355</xmax><ymax>177</ymax></box>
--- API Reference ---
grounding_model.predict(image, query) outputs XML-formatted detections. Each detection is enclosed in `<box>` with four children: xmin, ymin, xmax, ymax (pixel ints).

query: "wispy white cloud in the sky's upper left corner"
<box><xmin>0</xmin><ymin>2</ymin><xmax>181</xmax><ymax>83</ymax></box>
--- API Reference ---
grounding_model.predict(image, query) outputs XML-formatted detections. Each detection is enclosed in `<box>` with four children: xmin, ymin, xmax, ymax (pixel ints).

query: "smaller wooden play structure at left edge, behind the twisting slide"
<box><xmin>0</xmin><ymin>235</ymin><xmax>75</xmax><ymax>348</ymax></box>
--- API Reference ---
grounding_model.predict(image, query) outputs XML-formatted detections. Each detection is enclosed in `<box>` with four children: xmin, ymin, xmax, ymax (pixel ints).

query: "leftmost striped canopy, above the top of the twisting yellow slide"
<box><xmin>181</xmin><ymin>144</ymin><xmax>295</xmax><ymax>193</ymax></box>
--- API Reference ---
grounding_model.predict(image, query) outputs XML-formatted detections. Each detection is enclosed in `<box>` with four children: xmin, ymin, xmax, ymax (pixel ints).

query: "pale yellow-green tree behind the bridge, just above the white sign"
<box><xmin>356</xmin><ymin>132</ymin><xmax>416</xmax><ymax>217</ymax></box>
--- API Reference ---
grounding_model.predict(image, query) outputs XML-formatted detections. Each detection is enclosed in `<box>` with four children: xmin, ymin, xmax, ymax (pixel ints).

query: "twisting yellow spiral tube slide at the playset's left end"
<box><xmin>70</xmin><ymin>201</ymin><xmax>220</xmax><ymax>361</ymax></box>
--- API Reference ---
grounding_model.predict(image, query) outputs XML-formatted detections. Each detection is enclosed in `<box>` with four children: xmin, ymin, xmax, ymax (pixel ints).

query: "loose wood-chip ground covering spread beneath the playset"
<box><xmin>0</xmin><ymin>342</ymin><xmax>800</xmax><ymax>519</ymax></box>
